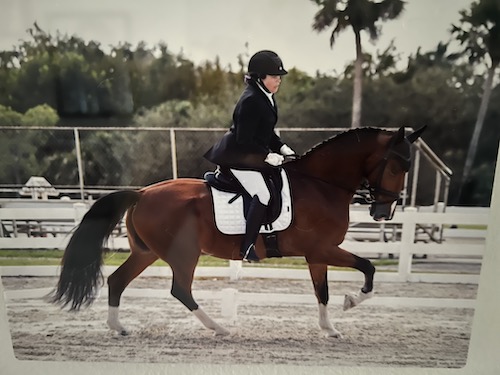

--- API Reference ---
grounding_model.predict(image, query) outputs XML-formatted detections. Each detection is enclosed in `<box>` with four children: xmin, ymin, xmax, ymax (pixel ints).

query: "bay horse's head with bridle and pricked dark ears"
<box><xmin>368</xmin><ymin>126</ymin><xmax>426</xmax><ymax>221</ymax></box>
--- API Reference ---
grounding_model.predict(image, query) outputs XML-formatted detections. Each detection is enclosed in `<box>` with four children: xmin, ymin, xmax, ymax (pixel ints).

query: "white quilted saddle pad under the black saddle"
<box><xmin>210</xmin><ymin>169</ymin><xmax>292</xmax><ymax>234</ymax></box>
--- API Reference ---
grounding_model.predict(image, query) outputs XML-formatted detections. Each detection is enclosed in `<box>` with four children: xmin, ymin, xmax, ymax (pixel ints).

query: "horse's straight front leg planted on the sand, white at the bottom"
<box><xmin>309</xmin><ymin>264</ymin><xmax>342</xmax><ymax>338</ymax></box>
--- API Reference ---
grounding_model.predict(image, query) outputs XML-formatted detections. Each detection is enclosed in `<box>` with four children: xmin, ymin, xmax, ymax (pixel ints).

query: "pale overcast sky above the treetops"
<box><xmin>0</xmin><ymin>0</ymin><xmax>472</xmax><ymax>75</ymax></box>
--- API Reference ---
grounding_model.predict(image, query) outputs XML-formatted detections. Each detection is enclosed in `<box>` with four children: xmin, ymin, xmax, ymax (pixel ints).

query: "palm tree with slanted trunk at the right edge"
<box><xmin>451</xmin><ymin>0</ymin><xmax>500</xmax><ymax>203</ymax></box>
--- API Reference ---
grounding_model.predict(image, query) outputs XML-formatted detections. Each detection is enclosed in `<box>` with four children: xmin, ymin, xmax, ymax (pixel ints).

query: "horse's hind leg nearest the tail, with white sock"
<box><xmin>107</xmin><ymin>250</ymin><xmax>158</xmax><ymax>335</ymax></box>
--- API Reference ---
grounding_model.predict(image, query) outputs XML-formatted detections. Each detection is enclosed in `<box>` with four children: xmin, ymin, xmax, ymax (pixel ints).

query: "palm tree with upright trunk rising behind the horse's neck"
<box><xmin>311</xmin><ymin>0</ymin><xmax>405</xmax><ymax>128</ymax></box>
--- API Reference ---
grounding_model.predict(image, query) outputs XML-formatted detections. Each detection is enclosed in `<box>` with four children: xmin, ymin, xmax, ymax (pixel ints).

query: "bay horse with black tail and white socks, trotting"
<box><xmin>51</xmin><ymin>127</ymin><xmax>425</xmax><ymax>337</ymax></box>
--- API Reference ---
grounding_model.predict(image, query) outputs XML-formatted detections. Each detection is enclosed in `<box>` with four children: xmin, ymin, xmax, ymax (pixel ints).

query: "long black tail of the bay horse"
<box><xmin>50</xmin><ymin>191</ymin><xmax>140</xmax><ymax>310</ymax></box>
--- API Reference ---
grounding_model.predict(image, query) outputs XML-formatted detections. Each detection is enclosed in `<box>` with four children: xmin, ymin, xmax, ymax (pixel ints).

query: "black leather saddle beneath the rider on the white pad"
<box><xmin>203</xmin><ymin>167</ymin><xmax>283</xmax><ymax>225</ymax></box>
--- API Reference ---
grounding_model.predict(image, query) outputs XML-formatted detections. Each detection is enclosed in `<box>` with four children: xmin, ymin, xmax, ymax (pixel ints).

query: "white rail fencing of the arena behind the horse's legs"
<box><xmin>0</xmin><ymin>203</ymin><xmax>489</xmax><ymax>284</ymax></box>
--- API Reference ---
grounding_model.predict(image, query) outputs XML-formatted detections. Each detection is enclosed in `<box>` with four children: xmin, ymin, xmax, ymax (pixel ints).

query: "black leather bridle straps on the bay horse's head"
<box><xmin>360</xmin><ymin>140</ymin><xmax>411</xmax><ymax>204</ymax></box>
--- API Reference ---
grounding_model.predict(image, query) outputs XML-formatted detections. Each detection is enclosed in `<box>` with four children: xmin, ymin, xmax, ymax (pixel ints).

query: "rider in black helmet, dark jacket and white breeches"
<box><xmin>204</xmin><ymin>50</ymin><xmax>295</xmax><ymax>262</ymax></box>
